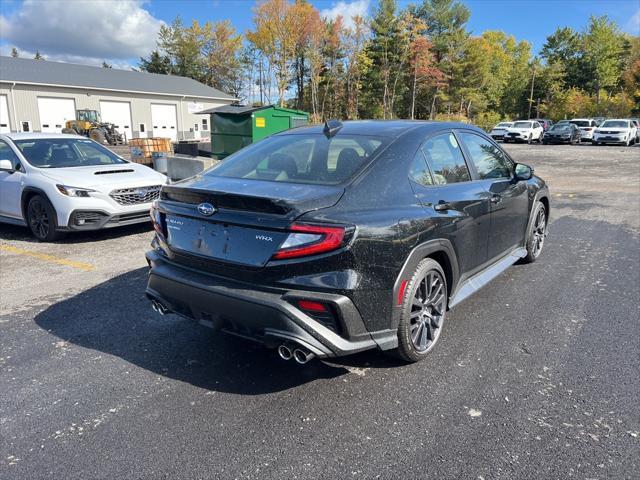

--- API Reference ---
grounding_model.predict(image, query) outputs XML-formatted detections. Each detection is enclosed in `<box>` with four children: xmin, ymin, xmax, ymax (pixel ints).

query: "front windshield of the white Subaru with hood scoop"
<box><xmin>13</xmin><ymin>138</ymin><xmax>127</xmax><ymax>168</ymax></box>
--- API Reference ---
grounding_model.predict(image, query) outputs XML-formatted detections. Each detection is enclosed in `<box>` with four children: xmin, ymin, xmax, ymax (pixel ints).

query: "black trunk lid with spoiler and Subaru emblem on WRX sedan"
<box><xmin>160</xmin><ymin>177</ymin><xmax>344</xmax><ymax>267</ymax></box>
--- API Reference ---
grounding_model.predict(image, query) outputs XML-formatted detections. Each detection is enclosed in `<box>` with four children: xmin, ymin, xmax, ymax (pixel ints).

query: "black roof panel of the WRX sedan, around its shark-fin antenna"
<box><xmin>276</xmin><ymin>120</ymin><xmax>484</xmax><ymax>138</ymax></box>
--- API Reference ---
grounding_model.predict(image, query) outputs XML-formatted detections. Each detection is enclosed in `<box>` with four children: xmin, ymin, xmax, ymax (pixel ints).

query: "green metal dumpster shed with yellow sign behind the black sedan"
<box><xmin>199</xmin><ymin>105</ymin><xmax>309</xmax><ymax>160</ymax></box>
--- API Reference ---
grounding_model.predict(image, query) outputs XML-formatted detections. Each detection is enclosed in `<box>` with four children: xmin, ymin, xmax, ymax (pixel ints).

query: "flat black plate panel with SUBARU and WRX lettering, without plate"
<box><xmin>166</xmin><ymin>215</ymin><xmax>286</xmax><ymax>267</ymax></box>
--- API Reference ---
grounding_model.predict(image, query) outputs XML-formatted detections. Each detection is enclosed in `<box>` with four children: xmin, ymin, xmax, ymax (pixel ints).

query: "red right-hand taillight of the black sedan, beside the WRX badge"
<box><xmin>271</xmin><ymin>223</ymin><xmax>345</xmax><ymax>260</ymax></box>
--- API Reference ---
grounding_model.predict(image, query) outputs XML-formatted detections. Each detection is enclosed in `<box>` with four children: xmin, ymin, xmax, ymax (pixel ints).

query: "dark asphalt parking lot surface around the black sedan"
<box><xmin>0</xmin><ymin>141</ymin><xmax>640</xmax><ymax>479</ymax></box>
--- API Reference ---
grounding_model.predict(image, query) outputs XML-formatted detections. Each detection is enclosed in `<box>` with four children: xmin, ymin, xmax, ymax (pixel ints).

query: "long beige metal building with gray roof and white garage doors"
<box><xmin>0</xmin><ymin>57</ymin><xmax>236</xmax><ymax>141</ymax></box>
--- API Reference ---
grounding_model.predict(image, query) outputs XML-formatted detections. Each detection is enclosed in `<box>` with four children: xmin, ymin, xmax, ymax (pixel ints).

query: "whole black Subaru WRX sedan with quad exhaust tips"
<box><xmin>147</xmin><ymin>121</ymin><xmax>549</xmax><ymax>363</ymax></box>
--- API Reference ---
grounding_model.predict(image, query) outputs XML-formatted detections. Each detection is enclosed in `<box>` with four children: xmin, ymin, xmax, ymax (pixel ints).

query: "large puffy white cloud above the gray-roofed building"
<box><xmin>0</xmin><ymin>0</ymin><xmax>163</xmax><ymax>66</ymax></box>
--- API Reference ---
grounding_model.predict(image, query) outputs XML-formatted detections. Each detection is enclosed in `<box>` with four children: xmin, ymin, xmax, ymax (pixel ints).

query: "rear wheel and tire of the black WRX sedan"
<box><xmin>391</xmin><ymin>258</ymin><xmax>448</xmax><ymax>362</ymax></box>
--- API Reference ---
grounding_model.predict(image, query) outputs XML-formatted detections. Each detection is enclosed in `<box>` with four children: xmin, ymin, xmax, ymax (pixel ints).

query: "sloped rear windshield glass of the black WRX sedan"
<box><xmin>205</xmin><ymin>134</ymin><xmax>388</xmax><ymax>185</ymax></box>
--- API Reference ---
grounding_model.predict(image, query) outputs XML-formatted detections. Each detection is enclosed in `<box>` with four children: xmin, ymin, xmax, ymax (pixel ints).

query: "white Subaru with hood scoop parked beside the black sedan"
<box><xmin>0</xmin><ymin>133</ymin><xmax>167</xmax><ymax>241</ymax></box>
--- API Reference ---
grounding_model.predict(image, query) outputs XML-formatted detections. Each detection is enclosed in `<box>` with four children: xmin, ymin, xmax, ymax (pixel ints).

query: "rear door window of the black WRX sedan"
<box><xmin>422</xmin><ymin>133</ymin><xmax>471</xmax><ymax>185</ymax></box>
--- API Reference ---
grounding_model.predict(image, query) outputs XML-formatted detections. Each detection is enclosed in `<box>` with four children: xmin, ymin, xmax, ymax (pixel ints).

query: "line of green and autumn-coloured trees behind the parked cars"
<box><xmin>139</xmin><ymin>0</ymin><xmax>640</xmax><ymax>128</ymax></box>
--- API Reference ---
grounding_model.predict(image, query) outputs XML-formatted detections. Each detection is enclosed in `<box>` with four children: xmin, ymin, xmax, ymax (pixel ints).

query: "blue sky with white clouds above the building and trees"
<box><xmin>0</xmin><ymin>0</ymin><xmax>640</xmax><ymax>68</ymax></box>
